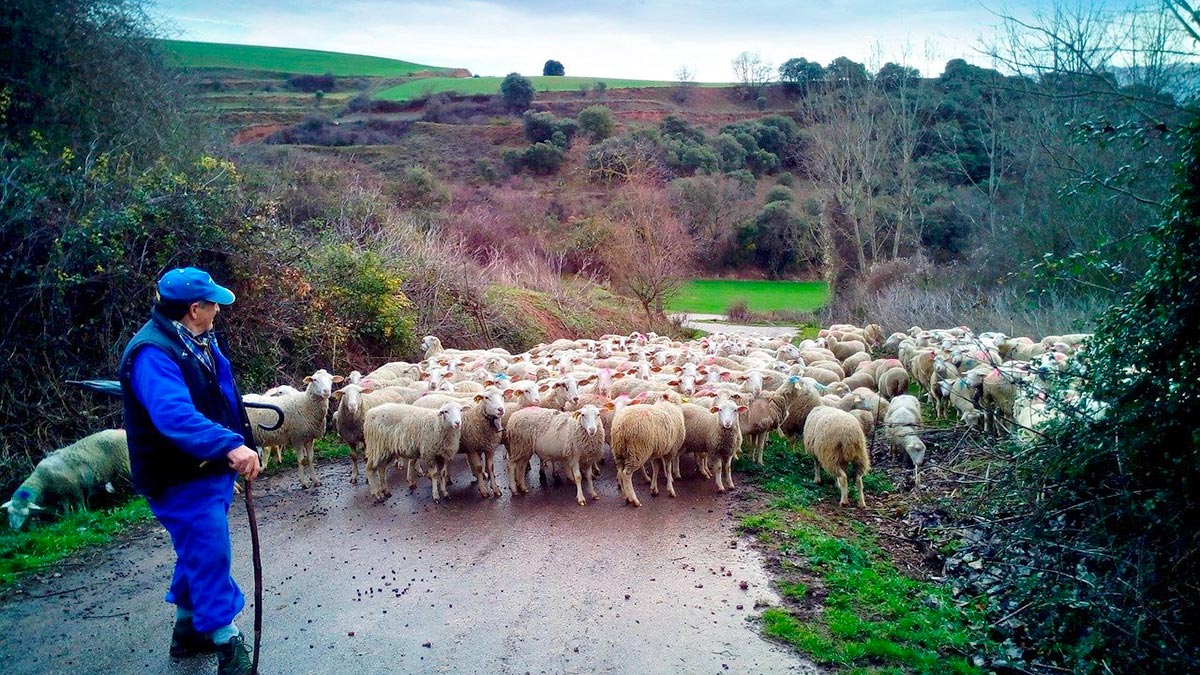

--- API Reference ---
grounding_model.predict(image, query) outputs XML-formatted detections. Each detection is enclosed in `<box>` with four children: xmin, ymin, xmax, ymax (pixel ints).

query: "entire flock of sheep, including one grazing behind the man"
<box><xmin>4</xmin><ymin>324</ymin><xmax>1088</xmax><ymax>528</ymax></box>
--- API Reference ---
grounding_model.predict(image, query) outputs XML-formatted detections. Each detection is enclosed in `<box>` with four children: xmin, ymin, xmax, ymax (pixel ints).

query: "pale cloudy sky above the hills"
<box><xmin>147</xmin><ymin>0</ymin><xmax>1122</xmax><ymax>82</ymax></box>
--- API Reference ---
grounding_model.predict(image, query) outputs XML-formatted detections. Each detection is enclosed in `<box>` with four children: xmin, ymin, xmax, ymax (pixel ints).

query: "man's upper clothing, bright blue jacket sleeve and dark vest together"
<box><xmin>120</xmin><ymin>311</ymin><xmax>254</xmax><ymax>497</ymax></box>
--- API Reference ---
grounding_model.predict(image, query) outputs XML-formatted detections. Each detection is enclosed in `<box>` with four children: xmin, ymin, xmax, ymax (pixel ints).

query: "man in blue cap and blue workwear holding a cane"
<box><xmin>120</xmin><ymin>267</ymin><xmax>260</xmax><ymax>675</ymax></box>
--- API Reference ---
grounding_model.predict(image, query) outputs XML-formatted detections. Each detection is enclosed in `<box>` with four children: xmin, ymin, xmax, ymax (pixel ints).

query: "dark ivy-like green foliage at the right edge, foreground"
<box><xmin>969</xmin><ymin>114</ymin><xmax>1200</xmax><ymax>674</ymax></box>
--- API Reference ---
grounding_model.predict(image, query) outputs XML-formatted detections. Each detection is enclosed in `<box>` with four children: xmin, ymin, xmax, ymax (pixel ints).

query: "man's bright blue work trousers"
<box><xmin>146</xmin><ymin>472</ymin><xmax>246</xmax><ymax>633</ymax></box>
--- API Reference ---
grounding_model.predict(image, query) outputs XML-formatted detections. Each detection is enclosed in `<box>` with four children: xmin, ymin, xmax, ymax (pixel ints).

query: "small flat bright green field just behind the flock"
<box><xmin>667</xmin><ymin>279</ymin><xmax>829</xmax><ymax>315</ymax></box>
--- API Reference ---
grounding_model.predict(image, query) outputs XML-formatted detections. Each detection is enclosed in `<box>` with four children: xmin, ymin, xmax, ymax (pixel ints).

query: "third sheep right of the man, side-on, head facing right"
<box><xmin>362</xmin><ymin>401</ymin><xmax>463</xmax><ymax>503</ymax></box>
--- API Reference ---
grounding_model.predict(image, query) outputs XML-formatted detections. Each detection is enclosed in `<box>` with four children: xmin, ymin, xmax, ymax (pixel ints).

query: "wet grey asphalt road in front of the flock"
<box><xmin>0</xmin><ymin>459</ymin><xmax>815</xmax><ymax>675</ymax></box>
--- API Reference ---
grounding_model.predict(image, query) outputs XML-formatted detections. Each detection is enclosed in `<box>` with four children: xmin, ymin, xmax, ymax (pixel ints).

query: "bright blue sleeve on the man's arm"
<box><xmin>131</xmin><ymin>347</ymin><xmax>245</xmax><ymax>460</ymax></box>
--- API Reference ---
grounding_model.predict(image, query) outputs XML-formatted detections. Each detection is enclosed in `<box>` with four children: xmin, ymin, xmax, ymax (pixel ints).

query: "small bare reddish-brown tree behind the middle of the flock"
<box><xmin>605</xmin><ymin>184</ymin><xmax>696</xmax><ymax>319</ymax></box>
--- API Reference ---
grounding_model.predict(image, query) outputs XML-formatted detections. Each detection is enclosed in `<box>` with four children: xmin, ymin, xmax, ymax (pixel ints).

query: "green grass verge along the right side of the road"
<box><xmin>736</xmin><ymin>432</ymin><xmax>992</xmax><ymax>675</ymax></box>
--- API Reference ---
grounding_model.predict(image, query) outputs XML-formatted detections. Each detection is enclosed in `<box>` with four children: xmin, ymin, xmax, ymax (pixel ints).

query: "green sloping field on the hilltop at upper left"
<box><xmin>162</xmin><ymin>40</ymin><xmax>449</xmax><ymax>77</ymax></box>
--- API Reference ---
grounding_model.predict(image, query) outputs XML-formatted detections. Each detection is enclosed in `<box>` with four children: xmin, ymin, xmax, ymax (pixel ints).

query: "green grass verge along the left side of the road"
<box><xmin>0</xmin><ymin>435</ymin><xmax>350</xmax><ymax>589</ymax></box>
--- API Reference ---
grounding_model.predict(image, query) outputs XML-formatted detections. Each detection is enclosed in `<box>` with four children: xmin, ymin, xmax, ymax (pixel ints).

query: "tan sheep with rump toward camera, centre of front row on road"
<box><xmin>612</xmin><ymin>399</ymin><xmax>686</xmax><ymax>507</ymax></box>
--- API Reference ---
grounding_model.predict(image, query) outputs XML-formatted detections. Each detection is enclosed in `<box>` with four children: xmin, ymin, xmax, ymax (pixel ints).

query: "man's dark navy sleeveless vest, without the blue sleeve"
<box><xmin>120</xmin><ymin>311</ymin><xmax>253</xmax><ymax>497</ymax></box>
